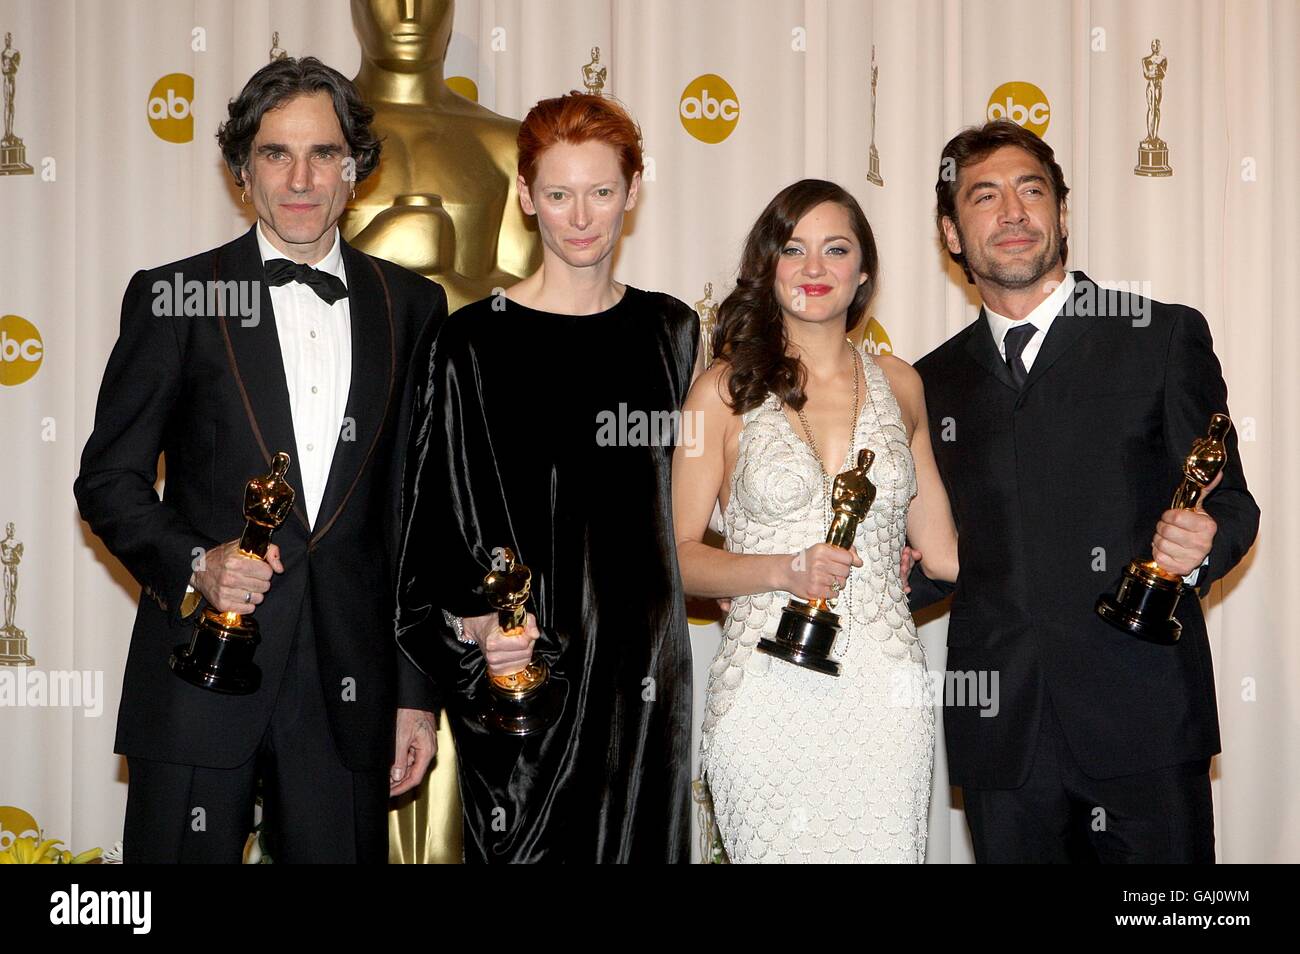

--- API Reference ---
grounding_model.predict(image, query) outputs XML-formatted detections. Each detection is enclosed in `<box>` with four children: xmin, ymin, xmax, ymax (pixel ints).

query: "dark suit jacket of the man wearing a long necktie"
<box><xmin>917</xmin><ymin>273</ymin><xmax>1260</xmax><ymax>788</ymax></box>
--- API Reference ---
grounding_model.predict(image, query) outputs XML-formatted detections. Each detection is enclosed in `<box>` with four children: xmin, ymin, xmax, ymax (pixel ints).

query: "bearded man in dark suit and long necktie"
<box><xmin>911</xmin><ymin>122</ymin><xmax>1260</xmax><ymax>862</ymax></box>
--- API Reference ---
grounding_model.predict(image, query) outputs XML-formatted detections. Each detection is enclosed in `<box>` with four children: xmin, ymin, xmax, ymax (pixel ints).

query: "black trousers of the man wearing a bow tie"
<box><xmin>122</xmin><ymin>613</ymin><xmax>389</xmax><ymax>864</ymax></box>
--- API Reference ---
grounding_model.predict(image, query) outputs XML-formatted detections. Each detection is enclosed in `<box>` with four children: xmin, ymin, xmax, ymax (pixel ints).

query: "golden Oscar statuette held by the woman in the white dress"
<box><xmin>758</xmin><ymin>448</ymin><xmax>876</xmax><ymax>676</ymax></box>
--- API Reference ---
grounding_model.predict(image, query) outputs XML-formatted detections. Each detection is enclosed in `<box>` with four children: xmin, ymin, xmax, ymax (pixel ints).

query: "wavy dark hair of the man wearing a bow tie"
<box><xmin>217</xmin><ymin>56</ymin><xmax>380</xmax><ymax>186</ymax></box>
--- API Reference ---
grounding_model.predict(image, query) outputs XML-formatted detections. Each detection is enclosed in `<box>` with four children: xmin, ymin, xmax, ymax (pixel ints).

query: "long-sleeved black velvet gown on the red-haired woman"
<box><xmin>397</xmin><ymin>286</ymin><xmax>699</xmax><ymax>862</ymax></box>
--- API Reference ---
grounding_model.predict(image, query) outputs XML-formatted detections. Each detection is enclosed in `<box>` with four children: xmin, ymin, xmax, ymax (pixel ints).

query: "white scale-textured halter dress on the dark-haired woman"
<box><xmin>701</xmin><ymin>348</ymin><xmax>935</xmax><ymax>863</ymax></box>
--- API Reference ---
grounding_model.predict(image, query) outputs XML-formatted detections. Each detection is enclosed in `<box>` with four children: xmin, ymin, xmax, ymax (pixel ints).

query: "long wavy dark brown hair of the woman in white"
<box><xmin>712</xmin><ymin>179</ymin><xmax>880</xmax><ymax>413</ymax></box>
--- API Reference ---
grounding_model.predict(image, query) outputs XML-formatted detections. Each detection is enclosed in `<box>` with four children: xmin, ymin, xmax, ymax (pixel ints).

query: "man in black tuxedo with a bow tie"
<box><xmin>74</xmin><ymin>57</ymin><xmax>446</xmax><ymax>863</ymax></box>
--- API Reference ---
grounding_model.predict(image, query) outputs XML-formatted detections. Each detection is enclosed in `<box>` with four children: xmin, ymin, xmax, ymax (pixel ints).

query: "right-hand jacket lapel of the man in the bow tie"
<box><xmin>311</xmin><ymin>237</ymin><xmax>397</xmax><ymax>545</ymax></box>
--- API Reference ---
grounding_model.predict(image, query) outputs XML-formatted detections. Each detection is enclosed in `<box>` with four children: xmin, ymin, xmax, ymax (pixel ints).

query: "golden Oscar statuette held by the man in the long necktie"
<box><xmin>1096</xmin><ymin>415</ymin><xmax>1232</xmax><ymax>646</ymax></box>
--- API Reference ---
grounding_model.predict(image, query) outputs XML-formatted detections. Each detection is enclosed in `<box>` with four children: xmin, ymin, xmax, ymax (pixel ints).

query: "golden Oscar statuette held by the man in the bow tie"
<box><xmin>169</xmin><ymin>451</ymin><xmax>294</xmax><ymax>695</ymax></box>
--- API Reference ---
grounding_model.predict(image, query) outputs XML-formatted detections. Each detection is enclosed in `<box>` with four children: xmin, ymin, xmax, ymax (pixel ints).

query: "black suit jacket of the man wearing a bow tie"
<box><xmin>74</xmin><ymin>226</ymin><xmax>447</xmax><ymax>771</ymax></box>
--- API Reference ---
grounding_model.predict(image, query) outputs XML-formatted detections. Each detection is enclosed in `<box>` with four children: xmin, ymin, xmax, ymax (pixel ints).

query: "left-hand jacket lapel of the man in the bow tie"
<box><xmin>212</xmin><ymin>225</ymin><xmax>311</xmax><ymax>533</ymax></box>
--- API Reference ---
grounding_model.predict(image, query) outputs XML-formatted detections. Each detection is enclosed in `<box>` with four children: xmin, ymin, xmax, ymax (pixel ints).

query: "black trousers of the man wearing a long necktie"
<box><xmin>963</xmin><ymin>695</ymin><xmax>1214</xmax><ymax>864</ymax></box>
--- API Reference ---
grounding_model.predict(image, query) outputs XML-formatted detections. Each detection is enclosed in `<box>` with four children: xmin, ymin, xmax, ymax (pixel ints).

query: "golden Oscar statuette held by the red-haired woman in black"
<box><xmin>481</xmin><ymin>547</ymin><xmax>559</xmax><ymax>736</ymax></box>
